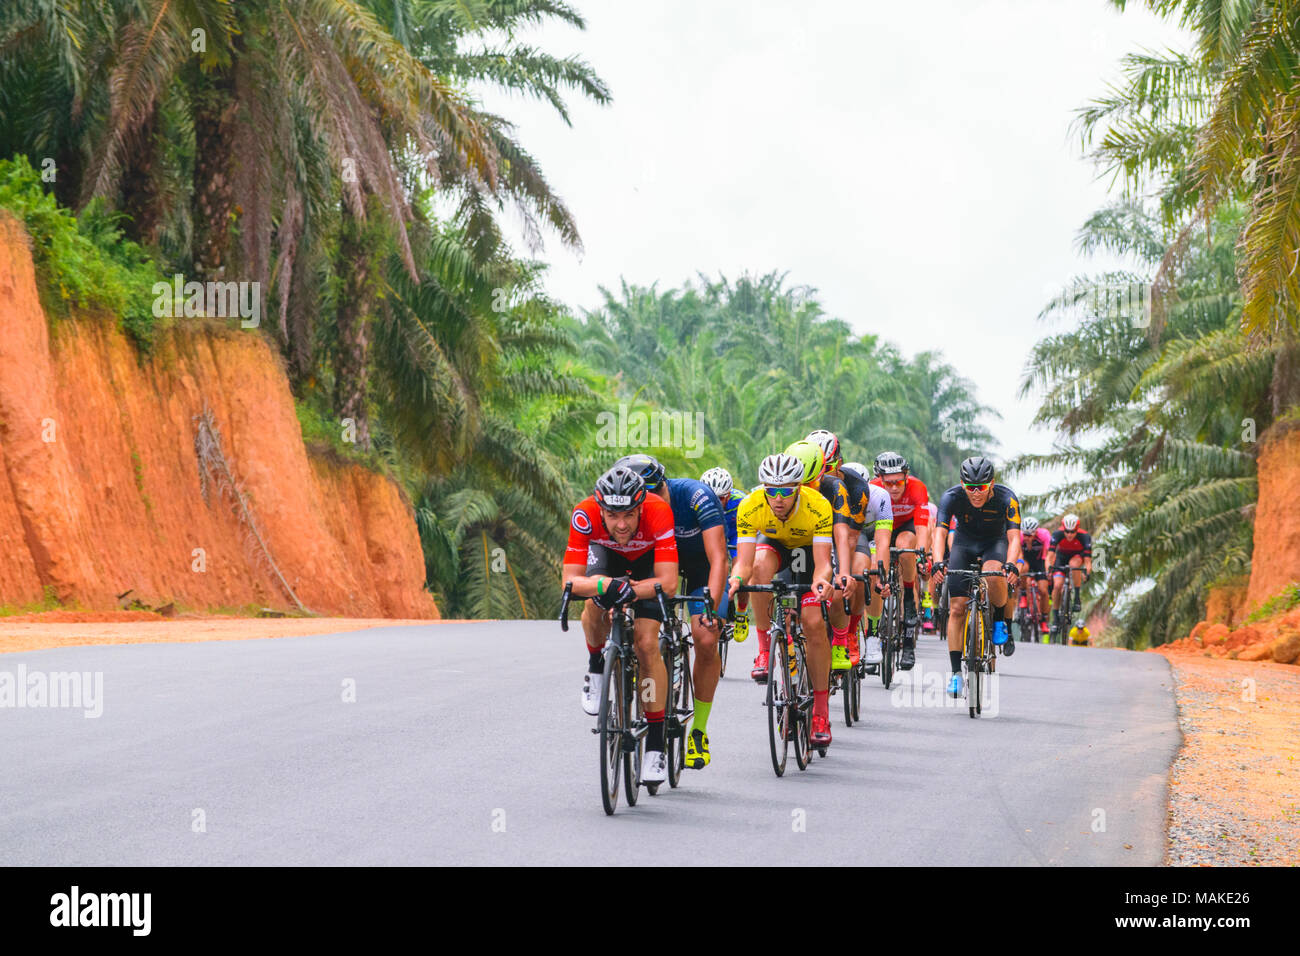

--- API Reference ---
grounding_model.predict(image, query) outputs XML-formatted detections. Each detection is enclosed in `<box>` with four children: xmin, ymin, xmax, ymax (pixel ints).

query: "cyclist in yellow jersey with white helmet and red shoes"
<box><xmin>729</xmin><ymin>454</ymin><xmax>832</xmax><ymax>747</ymax></box>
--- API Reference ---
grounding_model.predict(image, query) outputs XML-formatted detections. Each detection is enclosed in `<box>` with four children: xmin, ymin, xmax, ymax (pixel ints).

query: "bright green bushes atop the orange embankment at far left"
<box><xmin>0</xmin><ymin>156</ymin><xmax>163</xmax><ymax>351</ymax></box>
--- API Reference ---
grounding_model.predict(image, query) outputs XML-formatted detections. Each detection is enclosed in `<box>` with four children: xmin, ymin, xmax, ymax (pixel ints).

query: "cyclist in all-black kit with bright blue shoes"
<box><xmin>933</xmin><ymin>455</ymin><xmax>1021</xmax><ymax>697</ymax></box>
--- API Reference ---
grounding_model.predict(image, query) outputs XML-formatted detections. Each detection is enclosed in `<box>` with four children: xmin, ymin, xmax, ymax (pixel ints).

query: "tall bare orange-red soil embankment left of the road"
<box><xmin>0</xmin><ymin>213</ymin><xmax>438</xmax><ymax>618</ymax></box>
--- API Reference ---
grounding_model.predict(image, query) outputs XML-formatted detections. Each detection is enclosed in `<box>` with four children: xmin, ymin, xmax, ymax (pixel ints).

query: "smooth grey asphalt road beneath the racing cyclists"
<box><xmin>0</xmin><ymin>622</ymin><xmax>1179</xmax><ymax>865</ymax></box>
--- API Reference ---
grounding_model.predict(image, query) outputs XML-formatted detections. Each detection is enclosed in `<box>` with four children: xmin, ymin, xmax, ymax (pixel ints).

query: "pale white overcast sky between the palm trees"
<box><xmin>475</xmin><ymin>0</ymin><xmax>1183</xmax><ymax>492</ymax></box>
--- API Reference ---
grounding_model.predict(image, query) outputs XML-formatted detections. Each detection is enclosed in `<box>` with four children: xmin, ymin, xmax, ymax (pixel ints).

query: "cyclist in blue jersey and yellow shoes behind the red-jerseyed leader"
<box><xmin>618</xmin><ymin>454</ymin><xmax>727</xmax><ymax>770</ymax></box>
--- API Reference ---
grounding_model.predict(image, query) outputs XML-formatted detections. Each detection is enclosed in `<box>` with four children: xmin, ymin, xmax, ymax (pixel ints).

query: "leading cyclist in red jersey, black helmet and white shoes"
<box><xmin>564</xmin><ymin>466</ymin><xmax>677</xmax><ymax>783</ymax></box>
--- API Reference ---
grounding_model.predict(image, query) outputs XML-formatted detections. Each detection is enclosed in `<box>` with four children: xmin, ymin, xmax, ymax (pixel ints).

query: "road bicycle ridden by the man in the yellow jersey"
<box><xmin>737</xmin><ymin>580</ymin><xmax>831</xmax><ymax>777</ymax></box>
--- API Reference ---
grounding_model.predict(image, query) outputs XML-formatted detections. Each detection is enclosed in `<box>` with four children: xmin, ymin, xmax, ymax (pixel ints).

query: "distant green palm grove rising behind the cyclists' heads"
<box><xmin>575</xmin><ymin>272</ymin><xmax>996</xmax><ymax>486</ymax></box>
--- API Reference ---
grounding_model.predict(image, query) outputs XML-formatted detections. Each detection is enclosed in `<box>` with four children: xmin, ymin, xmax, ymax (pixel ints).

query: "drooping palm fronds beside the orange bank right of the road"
<box><xmin>1013</xmin><ymin>203</ymin><xmax>1274</xmax><ymax>646</ymax></box>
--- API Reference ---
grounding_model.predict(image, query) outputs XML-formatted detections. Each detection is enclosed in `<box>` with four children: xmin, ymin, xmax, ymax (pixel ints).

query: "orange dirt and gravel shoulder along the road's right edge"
<box><xmin>1157</xmin><ymin>650</ymin><xmax>1300</xmax><ymax>866</ymax></box>
